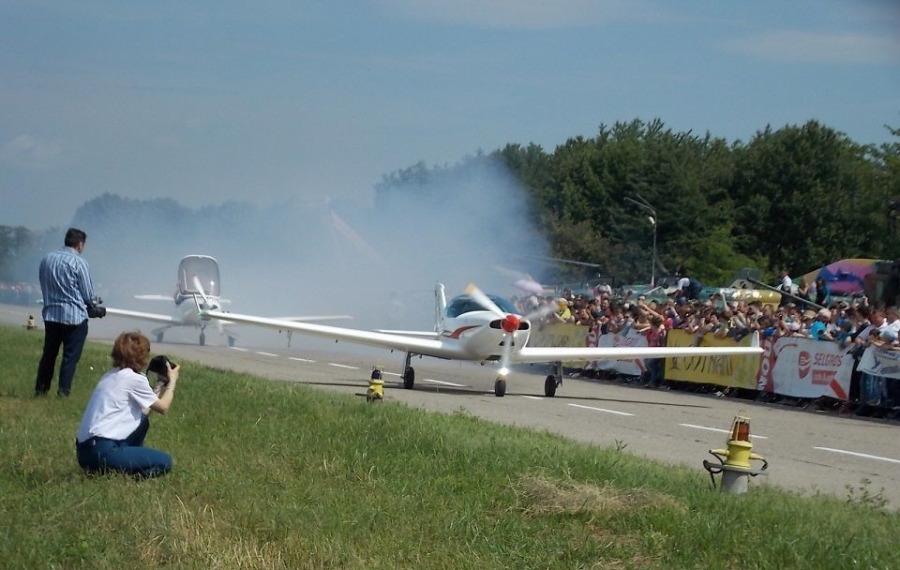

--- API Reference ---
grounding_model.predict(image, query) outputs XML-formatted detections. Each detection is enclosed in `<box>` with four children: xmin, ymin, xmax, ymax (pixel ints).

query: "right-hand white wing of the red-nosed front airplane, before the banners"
<box><xmin>511</xmin><ymin>341</ymin><xmax>762</xmax><ymax>363</ymax></box>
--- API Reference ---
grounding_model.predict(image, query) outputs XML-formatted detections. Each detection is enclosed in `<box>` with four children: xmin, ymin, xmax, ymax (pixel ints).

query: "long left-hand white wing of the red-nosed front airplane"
<box><xmin>201</xmin><ymin>311</ymin><xmax>461</xmax><ymax>358</ymax></box>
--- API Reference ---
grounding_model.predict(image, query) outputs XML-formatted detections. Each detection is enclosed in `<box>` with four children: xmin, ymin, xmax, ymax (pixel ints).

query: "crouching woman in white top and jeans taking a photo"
<box><xmin>75</xmin><ymin>332</ymin><xmax>179</xmax><ymax>477</ymax></box>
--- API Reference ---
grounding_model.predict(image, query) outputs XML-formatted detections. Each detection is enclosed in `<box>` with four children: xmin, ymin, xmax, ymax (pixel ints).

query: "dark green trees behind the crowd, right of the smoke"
<box><xmin>376</xmin><ymin>119</ymin><xmax>900</xmax><ymax>285</ymax></box>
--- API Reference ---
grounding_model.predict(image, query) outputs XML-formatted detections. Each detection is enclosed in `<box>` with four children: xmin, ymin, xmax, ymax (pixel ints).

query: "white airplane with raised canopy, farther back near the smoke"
<box><xmin>106</xmin><ymin>255</ymin><xmax>351</xmax><ymax>346</ymax></box>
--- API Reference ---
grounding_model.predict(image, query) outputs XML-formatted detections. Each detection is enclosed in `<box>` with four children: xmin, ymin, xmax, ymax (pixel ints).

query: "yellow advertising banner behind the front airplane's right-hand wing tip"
<box><xmin>665</xmin><ymin>329</ymin><xmax>759</xmax><ymax>390</ymax></box>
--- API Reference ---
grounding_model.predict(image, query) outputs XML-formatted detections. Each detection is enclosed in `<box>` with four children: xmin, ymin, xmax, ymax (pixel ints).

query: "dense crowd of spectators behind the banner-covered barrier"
<box><xmin>518</xmin><ymin>272</ymin><xmax>900</xmax><ymax>414</ymax></box>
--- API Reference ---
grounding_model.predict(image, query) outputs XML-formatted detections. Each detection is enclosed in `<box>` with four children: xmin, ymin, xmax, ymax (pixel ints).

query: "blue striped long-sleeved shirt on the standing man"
<box><xmin>40</xmin><ymin>247</ymin><xmax>96</xmax><ymax>325</ymax></box>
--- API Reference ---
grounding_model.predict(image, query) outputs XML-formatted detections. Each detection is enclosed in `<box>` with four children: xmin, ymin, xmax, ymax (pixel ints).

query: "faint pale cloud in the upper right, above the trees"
<box><xmin>725</xmin><ymin>30</ymin><xmax>900</xmax><ymax>65</ymax></box>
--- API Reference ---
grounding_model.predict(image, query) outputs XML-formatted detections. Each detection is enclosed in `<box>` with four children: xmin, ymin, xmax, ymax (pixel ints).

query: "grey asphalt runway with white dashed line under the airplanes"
<box><xmin>0</xmin><ymin>305</ymin><xmax>900</xmax><ymax>509</ymax></box>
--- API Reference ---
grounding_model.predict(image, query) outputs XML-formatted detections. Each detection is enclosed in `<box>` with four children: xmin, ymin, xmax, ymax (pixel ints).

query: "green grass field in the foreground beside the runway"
<box><xmin>0</xmin><ymin>327</ymin><xmax>900</xmax><ymax>570</ymax></box>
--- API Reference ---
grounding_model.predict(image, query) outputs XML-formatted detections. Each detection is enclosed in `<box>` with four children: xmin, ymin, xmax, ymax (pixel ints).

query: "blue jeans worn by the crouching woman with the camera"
<box><xmin>76</xmin><ymin>410</ymin><xmax>172</xmax><ymax>477</ymax></box>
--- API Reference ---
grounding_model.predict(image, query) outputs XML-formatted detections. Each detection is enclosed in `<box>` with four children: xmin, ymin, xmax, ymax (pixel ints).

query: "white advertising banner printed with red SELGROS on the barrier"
<box><xmin>759</xmin><ymin>337</ymin><xmax>853</xmax><ymax>400</ymax></box>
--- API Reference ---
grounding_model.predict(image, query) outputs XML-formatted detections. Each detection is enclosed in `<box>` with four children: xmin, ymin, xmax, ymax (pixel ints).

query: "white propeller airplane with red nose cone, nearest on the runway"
<box><xmin>200</xmin><ymin>283</ymin><xmax>762</xmax><ymax>397</ymax></box>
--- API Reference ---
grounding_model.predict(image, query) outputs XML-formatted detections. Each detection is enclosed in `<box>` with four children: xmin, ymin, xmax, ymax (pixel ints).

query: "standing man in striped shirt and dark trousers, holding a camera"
<box><xmin>34</xmin><ymin>228</ymin><xmax>106</xmax><ymax>396</ymax></box>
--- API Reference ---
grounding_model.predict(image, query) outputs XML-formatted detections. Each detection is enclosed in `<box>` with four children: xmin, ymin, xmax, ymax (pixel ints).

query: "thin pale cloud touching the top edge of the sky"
<box><xmin>383</xmin><ymin>0</ymin><xmax>651</xmax><ymax>29</ymax></box>
